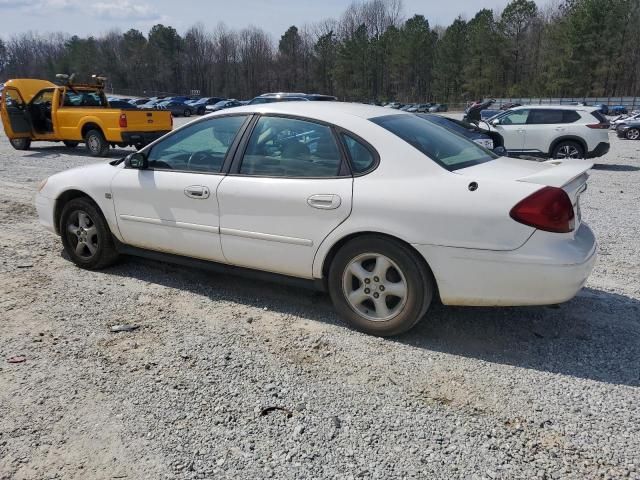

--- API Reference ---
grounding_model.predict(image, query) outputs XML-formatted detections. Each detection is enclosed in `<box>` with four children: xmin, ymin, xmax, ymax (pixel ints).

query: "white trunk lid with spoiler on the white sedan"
<box><xmin>456</xmin><ymin>157</ymin><xmax>593</xmax><ymax>230</ymax></box>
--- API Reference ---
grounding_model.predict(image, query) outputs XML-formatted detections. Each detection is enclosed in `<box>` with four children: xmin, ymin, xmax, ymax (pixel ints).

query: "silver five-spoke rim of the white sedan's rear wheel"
<box><xmin>342</xmin><ymin>253</ymin><xmax>408</xmax><ymax>322</ymax></box>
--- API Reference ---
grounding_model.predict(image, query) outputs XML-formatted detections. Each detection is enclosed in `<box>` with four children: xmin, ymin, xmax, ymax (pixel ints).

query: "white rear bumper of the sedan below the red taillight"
<box><xmin>414</xmin><ymin>223</ymin><xmax>597</xmax><ymax>306</ymax></box>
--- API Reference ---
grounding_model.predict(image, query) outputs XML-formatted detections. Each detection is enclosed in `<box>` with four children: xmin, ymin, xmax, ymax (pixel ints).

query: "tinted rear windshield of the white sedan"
<box><xmin>369</xmin><ymin>115</ymin><xmax>497</xmax><ymax>170</ymax></box>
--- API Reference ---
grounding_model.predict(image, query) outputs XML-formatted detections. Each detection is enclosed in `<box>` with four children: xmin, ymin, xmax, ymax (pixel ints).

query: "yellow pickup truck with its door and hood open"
<box><xmin>0</xmin><ymin>78</ymin><xmax>173</xmax><ymax>157</ymax></box>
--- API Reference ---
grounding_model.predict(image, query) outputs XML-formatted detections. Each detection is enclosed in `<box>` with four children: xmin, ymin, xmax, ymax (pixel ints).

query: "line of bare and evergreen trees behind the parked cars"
<box><xmin>0</xmin><ymin>0</ymin><xmax>640</xmax><ymax>103</ymax></box>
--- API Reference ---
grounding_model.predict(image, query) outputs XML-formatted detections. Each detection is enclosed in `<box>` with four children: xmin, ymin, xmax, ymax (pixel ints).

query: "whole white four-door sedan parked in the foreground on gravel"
<box><xmin>36</xmin><ymin>102</ymin><xmax>596</xmax><ymax>335</ymax></box>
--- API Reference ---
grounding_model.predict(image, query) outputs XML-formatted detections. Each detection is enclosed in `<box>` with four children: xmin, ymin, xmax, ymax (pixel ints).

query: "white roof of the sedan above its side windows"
<box><xmin>205</xmin><ymin>102</ymin><xmax>404</xmax><ymax>123</ymax></box>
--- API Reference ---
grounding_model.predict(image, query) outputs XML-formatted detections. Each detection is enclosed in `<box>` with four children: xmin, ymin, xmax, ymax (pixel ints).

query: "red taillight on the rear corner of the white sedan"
<box><xmin>509</xmin><ymin>187</ymin><xmax>575</xmax><ymax>233</ymax></box>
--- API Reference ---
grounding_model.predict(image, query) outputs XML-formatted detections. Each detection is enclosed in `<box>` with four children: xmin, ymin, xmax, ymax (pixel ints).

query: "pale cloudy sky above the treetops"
<box><xmin>0</xmin><ymin>0</ymin><xmax>553</xmax><ymax>39</ymax></box>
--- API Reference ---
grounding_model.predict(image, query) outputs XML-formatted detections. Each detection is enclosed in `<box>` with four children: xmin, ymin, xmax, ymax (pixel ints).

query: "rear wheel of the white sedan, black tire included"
<box><xmin>328</xmin><ymin>235</ymin><xmax>435</xmax><ymax>337</ymax></box>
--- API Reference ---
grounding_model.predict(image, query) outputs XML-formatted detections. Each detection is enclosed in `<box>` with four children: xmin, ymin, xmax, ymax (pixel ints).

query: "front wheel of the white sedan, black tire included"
<box><xmin>59</xmin><ymin>198</ymin><xmax>118</xmax><ymax>270</ymax></box>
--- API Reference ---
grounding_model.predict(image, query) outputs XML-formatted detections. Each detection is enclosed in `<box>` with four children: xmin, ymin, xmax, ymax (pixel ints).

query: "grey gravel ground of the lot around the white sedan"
<box><xmin>0</xmin><ymin>117</ymin><xmax>640</xmax><ymax>480</ymax></box>
